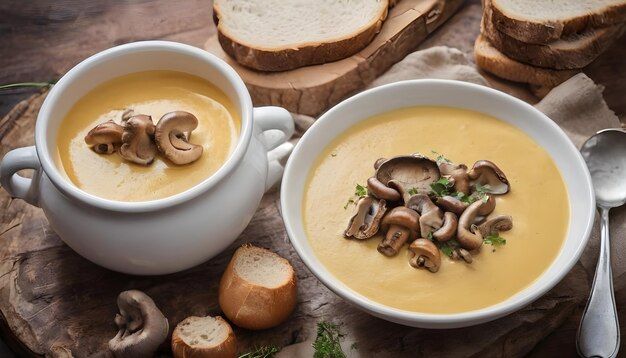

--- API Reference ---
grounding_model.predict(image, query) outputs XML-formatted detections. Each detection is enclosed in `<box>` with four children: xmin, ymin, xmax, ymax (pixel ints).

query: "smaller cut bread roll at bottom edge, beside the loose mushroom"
<box><xmin>172</xmin><ymin>316</ymin><xmax>237</xmax><ymax>358</ymax></box>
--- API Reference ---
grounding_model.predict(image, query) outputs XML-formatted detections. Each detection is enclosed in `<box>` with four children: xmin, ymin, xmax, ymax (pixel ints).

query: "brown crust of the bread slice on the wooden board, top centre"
<box><xmin>213</xmin><ymin>0</ymin><xmax>389</xmax><ymax>72</ymax></box>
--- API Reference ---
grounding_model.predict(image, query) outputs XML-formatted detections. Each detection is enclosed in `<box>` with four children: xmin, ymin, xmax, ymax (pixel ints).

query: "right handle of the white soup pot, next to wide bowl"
<box><xmin>254</xmin><ymin>107</ymin><xmax>294</xmax><ymax>191</ymax></box>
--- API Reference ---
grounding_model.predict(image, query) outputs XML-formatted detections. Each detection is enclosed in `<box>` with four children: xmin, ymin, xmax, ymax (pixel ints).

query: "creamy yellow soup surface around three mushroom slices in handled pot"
<box><xmin>57</xmin><ymin>71</ymin><xmax>241</xmax><ymax>201</ymax></box>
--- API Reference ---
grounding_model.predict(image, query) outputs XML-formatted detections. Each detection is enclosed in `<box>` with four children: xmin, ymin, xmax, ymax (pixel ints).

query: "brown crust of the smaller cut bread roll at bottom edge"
<box><xmin>172</xmin><ymin>316</ymin><xmax>237</xmax><ymax>358</ymax></box>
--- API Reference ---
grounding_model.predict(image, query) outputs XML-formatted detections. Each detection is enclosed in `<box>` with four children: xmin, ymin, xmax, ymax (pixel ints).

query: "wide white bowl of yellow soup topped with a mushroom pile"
<box><xmin>281</xmin><ymin>80</ymin><xmax>594</xmax><ymax>328</ymax></box>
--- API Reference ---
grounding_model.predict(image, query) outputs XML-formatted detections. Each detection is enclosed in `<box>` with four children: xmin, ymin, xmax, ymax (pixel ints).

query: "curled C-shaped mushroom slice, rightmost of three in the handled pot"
<box><xmin>154</xmin><ymin>111</ymin><xmax>203</xmax><ymax>165</ymax></box>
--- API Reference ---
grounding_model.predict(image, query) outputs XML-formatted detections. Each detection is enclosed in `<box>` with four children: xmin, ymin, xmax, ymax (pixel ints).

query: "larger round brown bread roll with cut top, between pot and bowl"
<box><xmin>219</xmin><ymin>245</ymin><xmax>298</xmax><ymax>329</ymax></box>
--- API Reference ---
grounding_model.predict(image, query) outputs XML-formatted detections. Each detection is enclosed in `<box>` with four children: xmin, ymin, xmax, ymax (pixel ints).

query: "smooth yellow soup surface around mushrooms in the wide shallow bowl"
<box><xmin>303</xmin><ymin>107</ymin><xmax>569</xmax><ymax>313</ymax></box>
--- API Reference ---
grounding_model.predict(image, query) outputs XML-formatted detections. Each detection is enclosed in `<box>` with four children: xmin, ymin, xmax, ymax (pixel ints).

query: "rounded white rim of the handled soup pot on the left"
<box><xmin>35</xmin><ymin>41</ymin><xmax>253</xmax><ymax>212</ymax></box>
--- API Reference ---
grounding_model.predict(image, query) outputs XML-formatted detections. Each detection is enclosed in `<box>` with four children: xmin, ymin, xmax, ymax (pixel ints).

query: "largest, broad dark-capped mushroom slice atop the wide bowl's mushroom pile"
<box><xmin>376</xmin><ymin>155</ymin><xmax>441</xmax><ymax>203</ymax></box>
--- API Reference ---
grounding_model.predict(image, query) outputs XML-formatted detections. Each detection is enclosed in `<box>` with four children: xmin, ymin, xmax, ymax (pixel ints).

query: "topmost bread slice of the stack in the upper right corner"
<box><xmin>485</xmin><ymin>0</ymin><xmax>626</xmax><ymax>44</ymax></box>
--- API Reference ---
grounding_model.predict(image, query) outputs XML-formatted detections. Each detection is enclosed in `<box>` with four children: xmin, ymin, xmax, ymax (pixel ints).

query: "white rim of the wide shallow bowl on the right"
<box><xmin>281</xmin><ymin>79</ymin><xmax>595</xmax><ymax>328</ymax></box>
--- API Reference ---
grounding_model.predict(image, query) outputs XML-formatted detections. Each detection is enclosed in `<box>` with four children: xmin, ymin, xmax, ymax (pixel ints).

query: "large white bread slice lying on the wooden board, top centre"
<box><xmin>213</xmin><ymin>0</ymin><xmax>389</xmax><ymax>71</ymax></box>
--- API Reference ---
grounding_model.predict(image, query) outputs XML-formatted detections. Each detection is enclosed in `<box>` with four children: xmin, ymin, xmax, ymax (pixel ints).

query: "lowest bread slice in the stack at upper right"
<box><xmin>474</xmin><ymin>35</ymin><xmax>579</xmax><ymax>88</ymax></box>
